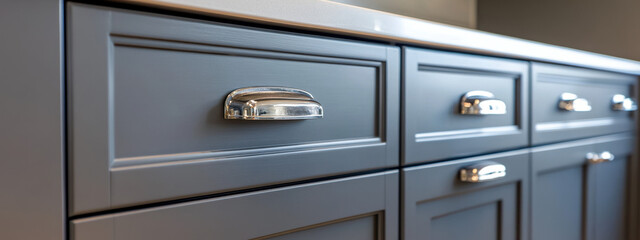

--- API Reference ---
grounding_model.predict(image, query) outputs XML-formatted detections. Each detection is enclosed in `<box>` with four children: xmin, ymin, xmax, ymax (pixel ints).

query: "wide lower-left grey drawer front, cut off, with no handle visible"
<box><xmin>71</xmin><ymin>171</ymin><xmax>399</xmax><ymax>240</ymax></box>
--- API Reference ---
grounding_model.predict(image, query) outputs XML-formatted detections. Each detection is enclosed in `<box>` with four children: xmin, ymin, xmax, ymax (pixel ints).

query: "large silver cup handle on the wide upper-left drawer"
<box><xmin>224</xmin><ymin>87</ymin><xmax>323</xmax><ymax>120</ymax></box>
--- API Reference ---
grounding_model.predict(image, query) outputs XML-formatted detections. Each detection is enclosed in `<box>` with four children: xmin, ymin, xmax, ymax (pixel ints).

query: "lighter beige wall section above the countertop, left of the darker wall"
<box><xmin>333</xmin><ymin>0</ymin><xmax>476</xmax><ymax>28</ymax></box>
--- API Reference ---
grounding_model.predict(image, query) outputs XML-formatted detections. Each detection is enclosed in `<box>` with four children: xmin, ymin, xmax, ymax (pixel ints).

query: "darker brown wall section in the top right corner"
<box><xmin>477</xmin><ymin>0</ymin><xmax>640</xmax><ymax>60</ymax></box>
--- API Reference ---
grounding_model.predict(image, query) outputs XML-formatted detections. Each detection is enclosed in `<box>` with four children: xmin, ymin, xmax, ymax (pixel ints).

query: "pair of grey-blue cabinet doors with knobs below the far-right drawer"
<box><xmin>531</xmin><ymin>134</ymin><xmax>633</xmax><ymax>240</ymax></box>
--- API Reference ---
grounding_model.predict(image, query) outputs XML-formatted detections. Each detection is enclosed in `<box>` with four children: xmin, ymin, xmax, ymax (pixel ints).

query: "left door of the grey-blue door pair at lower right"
<box><xmin>531</xmin><ymin>139</ymin><xmax>593</xmax><ymax>240</ymax></box>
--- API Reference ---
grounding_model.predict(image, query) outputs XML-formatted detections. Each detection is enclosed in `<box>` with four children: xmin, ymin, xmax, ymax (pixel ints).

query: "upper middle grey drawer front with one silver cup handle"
<box><xmin>403</xmin><ymin>48</ymin><xmax>529</xmax><ymax>164</ymax></box>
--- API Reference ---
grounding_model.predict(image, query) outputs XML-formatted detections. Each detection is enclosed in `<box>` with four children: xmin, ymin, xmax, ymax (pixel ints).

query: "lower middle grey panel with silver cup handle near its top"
<box><xmin>402</xmin><ymin>150</ymin><xmax>529</xmax><ymax>240</ymax></box>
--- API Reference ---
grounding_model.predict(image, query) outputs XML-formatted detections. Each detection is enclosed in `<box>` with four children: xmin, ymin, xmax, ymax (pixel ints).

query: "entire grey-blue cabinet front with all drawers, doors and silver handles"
<box><xmin>61</xmin><ymin>3</ymin><xmax>638</xmax><ymax>240</ymax></box>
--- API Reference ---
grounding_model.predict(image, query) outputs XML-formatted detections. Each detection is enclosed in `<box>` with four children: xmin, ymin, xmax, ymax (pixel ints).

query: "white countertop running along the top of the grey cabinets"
<box><xmin>118</xmin><ymin>0</ymin><xmax>640</xmax><ymax>75</ymax></box>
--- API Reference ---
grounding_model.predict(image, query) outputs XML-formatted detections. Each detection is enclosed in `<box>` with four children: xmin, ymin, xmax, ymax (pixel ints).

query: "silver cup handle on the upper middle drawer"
<box><xmin>460</xmin><ymin>91</ymin><xmax>507</xmax><ymax>115</ymax></box>
